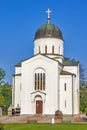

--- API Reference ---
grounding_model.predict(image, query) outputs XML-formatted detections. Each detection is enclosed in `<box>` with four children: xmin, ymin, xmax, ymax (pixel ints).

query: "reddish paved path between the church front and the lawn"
<box><xmin>0</xmin><ymin>115</ymin><xmax>87</xmax><ymax>123</ymax></box>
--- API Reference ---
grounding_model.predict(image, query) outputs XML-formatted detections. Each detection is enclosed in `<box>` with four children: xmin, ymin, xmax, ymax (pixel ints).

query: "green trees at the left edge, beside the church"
<box><xmin>0</xmin><ymin>68</ymin><xmax>12</xmax><ymax>112</ymax></box>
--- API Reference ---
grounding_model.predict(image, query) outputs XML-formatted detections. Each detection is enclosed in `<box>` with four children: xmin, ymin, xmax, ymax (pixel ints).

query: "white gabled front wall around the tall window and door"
<box><xmin>21</xmin><ymin>55</ymin><xmax>58</xmax><ymax>114</ymax></box>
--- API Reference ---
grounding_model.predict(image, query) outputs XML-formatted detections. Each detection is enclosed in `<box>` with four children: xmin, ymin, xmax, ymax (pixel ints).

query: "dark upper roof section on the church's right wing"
<box><xmin>63</xmin><ymin>58</ymin><xmax>79</xmax><ymax>66</ymax></box>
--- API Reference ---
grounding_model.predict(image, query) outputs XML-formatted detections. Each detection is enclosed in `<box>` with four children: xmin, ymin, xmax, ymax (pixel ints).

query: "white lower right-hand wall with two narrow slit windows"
<box><xmin>60</xmin><ymin>75</ymin><xmax>72</xmax><ymax>115</ymax></box>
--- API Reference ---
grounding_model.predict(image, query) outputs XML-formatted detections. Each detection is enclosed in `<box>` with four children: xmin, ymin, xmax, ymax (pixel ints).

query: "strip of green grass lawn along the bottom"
<box><xmin>4</xmin><ymin>123</ymin><xmax>87</xmax><ymax>130</ymax></box>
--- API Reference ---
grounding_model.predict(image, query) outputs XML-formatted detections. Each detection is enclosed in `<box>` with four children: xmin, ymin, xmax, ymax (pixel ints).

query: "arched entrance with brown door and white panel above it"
<box><xmin>35</xmin><ymin>95</ymin><xmax>43</xmax><ymax>114</ymax></box>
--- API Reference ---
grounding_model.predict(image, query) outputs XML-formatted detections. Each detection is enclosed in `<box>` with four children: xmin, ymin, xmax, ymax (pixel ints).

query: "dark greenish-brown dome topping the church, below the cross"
<box><xmin>34</xmin><ymin>23</ymin><xmax>63</xmax><ymax>40</ymax></box>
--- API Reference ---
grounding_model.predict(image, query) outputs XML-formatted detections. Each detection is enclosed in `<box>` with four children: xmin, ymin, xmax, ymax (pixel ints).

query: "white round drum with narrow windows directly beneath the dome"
<box><xmin>34</xmin><ymin>38</ymin><xmax>63</xmax><ymax>55</ymax></box>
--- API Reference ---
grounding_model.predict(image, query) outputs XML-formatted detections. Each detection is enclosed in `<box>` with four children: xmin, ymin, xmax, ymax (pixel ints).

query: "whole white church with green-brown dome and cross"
<box><xmin>12</xmin><ymin>9</ymin><xmax>79</xmax><ymax>115</ymax></box>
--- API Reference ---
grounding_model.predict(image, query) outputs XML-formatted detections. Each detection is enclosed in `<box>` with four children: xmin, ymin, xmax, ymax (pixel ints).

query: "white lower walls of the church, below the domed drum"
<box><xmin>14</xmin><ymin>54</ymin><xmax>79</xmax><ymax>115</ymax></box>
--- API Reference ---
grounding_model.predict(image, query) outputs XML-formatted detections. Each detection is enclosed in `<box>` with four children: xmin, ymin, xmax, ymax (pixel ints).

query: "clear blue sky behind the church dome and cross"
<box><xmin>0</xmin><ymin>0</ymin><xmax>87</xmax><ymax>84</ymax></box>
